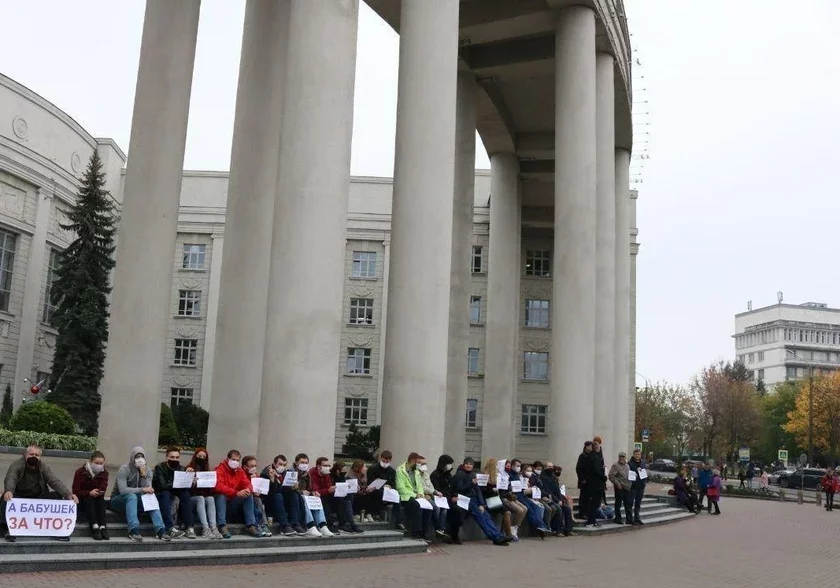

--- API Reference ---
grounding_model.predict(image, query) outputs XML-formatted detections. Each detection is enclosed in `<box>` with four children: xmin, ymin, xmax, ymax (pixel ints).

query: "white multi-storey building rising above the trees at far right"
<box><xmin>733</xmin><ymin>302</ymin><xmax>840</xmax><ymax>387</ymax></box>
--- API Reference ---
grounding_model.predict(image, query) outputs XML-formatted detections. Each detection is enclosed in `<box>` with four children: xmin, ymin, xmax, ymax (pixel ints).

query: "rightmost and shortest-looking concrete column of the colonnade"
<box><xmin>614</xmin><ymin>149</ymin><xmax>635</xmax><ymax>451</ymax></box>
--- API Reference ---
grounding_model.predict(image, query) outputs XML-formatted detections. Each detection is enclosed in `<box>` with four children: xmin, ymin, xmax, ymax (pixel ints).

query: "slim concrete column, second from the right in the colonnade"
<box><xmin>592</xmin><ymin>53</ymin><xmax>617</xmax><ymax>463</ymax></box>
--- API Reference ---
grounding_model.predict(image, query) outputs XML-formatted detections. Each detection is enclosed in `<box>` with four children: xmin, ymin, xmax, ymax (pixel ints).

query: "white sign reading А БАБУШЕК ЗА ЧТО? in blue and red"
<box><xmin>6</xmin><ymin>498</ymin><xmax>77</xmax><ymax>537</ymax></box>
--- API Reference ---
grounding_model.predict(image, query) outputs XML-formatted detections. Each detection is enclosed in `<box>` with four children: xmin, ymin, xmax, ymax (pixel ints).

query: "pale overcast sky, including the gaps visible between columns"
<box><xmin>0</xmin><ymin>0</ymin><xmax>840</xmax><ymax>383</ymax></box>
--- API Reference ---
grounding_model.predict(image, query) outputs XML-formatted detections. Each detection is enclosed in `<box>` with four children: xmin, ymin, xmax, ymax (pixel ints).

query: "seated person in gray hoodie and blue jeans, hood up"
<box><xmin>108</xmin><ymin>447</ymin><xmax>171</xmax><ymax>543</ymax></box>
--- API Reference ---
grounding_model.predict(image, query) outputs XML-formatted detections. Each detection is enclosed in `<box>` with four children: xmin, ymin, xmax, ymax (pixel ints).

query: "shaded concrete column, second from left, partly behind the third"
<box><xmin>207</xmin><ymin>0</ymin><xmax>291</xmax><ymax>457</ymax></box>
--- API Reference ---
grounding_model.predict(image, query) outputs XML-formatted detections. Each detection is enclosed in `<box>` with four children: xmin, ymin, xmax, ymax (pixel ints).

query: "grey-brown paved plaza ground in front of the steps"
<box><xmin>6</xmin><ymin>499</ymin><xmax>840</xmax><ymax>588</ymax></box>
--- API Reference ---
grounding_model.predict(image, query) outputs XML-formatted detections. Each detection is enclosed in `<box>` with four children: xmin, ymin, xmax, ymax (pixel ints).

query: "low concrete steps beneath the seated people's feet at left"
<box><xmin>0</xmin><ymin>539</ymin><xmax>427</xmax><ymax>573</ymax></box>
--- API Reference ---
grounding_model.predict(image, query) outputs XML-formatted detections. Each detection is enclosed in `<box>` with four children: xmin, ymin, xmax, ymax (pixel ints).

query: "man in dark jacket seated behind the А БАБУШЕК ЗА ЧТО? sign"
<box><xmin>0</xmin><ymin>445</ymin><xmax>79</xmax><ymax>542</ymax></box>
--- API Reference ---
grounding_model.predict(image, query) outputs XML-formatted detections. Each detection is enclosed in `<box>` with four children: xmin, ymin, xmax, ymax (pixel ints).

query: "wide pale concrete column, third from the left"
<box><xmin>259</xmin><ymin>0</ymin><xmax>359</xmax><ymax>460</ymax></box>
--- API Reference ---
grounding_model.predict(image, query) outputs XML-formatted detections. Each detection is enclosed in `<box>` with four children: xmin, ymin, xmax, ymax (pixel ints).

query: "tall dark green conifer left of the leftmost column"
<box><xmin>48</xmin><ymin>151</ymin><xmax>116</xmax><ymax>435</ymax></box>
